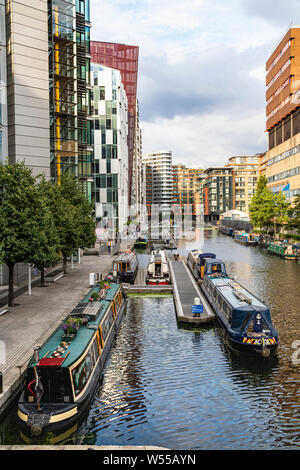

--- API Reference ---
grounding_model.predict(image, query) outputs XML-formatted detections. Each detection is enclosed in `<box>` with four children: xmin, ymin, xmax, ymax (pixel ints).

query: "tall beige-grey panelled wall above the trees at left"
<box><xmin>6</xmin><ymin>0</ymin><xmax>50</xmax><ymax>177</ymax></box>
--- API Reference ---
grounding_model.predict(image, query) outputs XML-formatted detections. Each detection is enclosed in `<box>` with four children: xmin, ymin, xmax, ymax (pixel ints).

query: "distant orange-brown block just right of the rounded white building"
<box><xmin>172</xmin><ymin>164</ymin><xmax>203</xmax><ymax>216</ymax></box>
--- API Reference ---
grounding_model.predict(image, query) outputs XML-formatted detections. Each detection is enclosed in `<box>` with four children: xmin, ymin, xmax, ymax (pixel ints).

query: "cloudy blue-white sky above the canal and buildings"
<box><xmin>90</xmin><ymin>0</ymin><xmax>300</xmax><ymax>168</ymax></box>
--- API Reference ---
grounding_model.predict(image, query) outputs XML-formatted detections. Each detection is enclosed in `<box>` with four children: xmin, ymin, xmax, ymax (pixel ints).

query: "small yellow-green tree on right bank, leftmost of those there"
<box><xmin>249</xmin><ymin>175</ymin><xmax>276</xmax><ymax>229</ymax></box>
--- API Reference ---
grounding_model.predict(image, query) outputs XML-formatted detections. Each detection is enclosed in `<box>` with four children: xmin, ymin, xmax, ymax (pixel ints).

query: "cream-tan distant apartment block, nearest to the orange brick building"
<box><xmin>227</xmin><ymin>155</ymin><xmax>260</xmax><ymax>214</ymax></box>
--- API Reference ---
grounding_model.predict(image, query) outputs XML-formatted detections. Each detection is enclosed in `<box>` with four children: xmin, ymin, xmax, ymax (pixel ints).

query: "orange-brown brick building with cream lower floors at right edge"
<box><xmin>265</xmin><ymin>26</ymin><xmax>300</xmax><ymax>201</ymax></box>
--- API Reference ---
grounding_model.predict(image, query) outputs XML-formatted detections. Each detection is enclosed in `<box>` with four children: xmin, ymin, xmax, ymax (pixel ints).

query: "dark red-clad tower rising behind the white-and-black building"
<box><xmin>91</xmin><ymin>41</ymin><xmax>139</xmax><ymax>204</ymax></box>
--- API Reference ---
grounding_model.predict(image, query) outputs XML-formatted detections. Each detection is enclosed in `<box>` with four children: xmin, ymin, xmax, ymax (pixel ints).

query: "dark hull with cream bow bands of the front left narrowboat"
<box><xmin>18</xmin><ymin>299</ymin><xmax>127</xmax><ymax>437</ymax></box>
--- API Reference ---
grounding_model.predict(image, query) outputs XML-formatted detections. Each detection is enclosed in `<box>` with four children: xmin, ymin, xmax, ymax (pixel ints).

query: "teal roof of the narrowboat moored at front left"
<box><xmin>29</xmin><ymin>281</ymin><xmax>121</xmax><ymax>367</ymax></box>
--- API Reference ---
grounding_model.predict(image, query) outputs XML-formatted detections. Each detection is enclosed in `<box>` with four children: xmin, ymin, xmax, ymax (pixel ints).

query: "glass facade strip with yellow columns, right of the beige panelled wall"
<box><xmin>48</xmin><ymin>0</ymin><xmax>78</xmax><ymax>185</ymax></box>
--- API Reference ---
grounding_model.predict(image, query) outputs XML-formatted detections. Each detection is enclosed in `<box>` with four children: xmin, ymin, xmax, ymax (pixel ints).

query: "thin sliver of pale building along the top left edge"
<box><xmin>0</xmin><ymin>0</ymin><xmax>8</xmax><ymax>163</ymax></box>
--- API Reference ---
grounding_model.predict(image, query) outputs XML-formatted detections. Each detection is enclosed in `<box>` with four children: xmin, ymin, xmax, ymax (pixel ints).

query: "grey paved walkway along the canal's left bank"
<box><xmin>0</xmin><ymin>250</ymin><xmax>127</xmax><ymax>414</ymax></box>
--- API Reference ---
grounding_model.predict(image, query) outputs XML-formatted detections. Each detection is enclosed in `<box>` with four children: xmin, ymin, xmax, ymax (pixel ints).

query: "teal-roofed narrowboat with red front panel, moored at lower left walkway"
<box><xmin>18</xmin><ymin>281</ymin><xmax>126</xmax><ymax>436</ymax></box>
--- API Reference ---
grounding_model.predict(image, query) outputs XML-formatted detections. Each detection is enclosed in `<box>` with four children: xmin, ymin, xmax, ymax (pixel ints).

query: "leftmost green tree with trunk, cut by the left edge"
<box><xmin>0</xmin><ymin>163</ymin><xmax>47</xmax><ymax>307</ymax></box>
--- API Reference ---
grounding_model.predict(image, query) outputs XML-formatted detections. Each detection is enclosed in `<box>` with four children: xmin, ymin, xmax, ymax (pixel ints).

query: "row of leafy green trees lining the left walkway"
<box><xmin>0</xmin><ymin>163</ymin><xmax>96</xmax><ymax>306</ymax></box>
